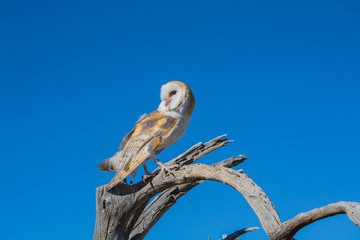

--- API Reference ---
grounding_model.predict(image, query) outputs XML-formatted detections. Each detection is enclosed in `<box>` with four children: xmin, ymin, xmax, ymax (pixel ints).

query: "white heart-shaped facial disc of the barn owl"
<box><xmin>160</xmin><ymin>82</ymin><xmax>184</xmax><ymax>112</ymax></box>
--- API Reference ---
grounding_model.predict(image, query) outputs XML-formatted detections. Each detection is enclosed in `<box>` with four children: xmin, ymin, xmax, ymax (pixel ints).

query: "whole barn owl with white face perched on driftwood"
<box><xmin>98</xmin><ymin>81</ymin><xmax>195</xmax><ymax>190</ymax></box>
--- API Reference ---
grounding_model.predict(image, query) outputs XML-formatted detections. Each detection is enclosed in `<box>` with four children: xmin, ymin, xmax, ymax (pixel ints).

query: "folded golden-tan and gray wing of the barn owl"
<box><xmin>106</xmin><ymin>111</ymin><xmax>179</xmax><ymax>190</ymax></box>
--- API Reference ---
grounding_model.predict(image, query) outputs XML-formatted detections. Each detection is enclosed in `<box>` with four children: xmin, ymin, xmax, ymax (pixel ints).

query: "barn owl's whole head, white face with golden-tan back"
<box><xmin>158</xmin><ymin>81</ymin><xmax>195</xmax><ymax>115</ymax></box>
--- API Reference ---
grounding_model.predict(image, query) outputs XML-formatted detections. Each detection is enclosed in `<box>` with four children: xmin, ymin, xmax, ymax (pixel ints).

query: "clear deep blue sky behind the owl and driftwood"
<box><xmin>0</xmin><ymin>0</ymin><xmax>360</xmax><ymax>240</ymax></box>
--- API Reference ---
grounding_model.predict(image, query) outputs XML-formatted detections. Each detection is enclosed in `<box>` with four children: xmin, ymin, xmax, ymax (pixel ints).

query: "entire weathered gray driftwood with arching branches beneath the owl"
<box><xmin>94</xmin><ymin>135</ymin><xmax>360</xmax><ymax>240</ymax></box>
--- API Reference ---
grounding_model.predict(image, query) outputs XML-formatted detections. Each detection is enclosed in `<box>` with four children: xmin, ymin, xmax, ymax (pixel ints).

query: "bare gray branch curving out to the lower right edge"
<box><xmin>270</xmin><ymin>202</ymin><xmax>360</xmax><ymax>240</ymax></box>
